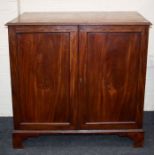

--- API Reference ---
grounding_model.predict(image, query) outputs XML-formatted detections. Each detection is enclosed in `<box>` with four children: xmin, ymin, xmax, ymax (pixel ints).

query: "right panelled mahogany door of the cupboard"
<box><xmin>79</xmin><ymin>26</ymin><xmax>146</xmax><ymax>129</ymax></box>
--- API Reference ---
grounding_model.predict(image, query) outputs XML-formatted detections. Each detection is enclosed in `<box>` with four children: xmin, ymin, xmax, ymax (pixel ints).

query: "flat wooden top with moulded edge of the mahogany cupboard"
<box><xmin>6</xmin><ymin>12</ymin><xmax>151</xmax><ymax>25</ymax></box>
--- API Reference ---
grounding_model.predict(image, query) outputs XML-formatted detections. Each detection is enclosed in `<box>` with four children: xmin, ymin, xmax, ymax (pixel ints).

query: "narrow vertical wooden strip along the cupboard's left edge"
<box><xmin>8</xmin><ymin>26</ymin><xmax>21</xmax><ymax>128</ymax></box>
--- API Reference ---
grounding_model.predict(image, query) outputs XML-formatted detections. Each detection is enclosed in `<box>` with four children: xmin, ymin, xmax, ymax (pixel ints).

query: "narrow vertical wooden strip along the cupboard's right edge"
<box><xmin>136</xmin><ymin>26</ymin><xmax>149</xmax><ymax>128</ymax></box>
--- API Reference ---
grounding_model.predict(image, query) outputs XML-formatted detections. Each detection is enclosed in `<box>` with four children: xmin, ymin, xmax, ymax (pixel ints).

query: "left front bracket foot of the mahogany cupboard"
<box><xmin>12</xmin><ymin>133</ymin><xmax>23</xmax><ymax>149</ymax></box>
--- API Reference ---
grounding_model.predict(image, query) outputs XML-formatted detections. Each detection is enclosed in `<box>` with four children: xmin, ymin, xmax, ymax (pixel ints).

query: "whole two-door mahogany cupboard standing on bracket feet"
<box><xmin>7</xmin><ymin>12</ymin><xmax>150</xmax><ymax>148</ymax></box>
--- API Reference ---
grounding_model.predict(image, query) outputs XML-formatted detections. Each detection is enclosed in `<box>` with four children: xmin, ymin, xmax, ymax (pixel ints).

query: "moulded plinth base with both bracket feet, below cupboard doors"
<box><xmin>12</xmin><ymin>129</ymin><xmax>144</xmax><ymax>149</ymax></box>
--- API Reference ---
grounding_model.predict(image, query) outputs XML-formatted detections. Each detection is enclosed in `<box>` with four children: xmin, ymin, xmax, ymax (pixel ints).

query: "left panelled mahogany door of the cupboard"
<box><xmin>9</xmin><ymin>26</ymin><xmax>77</xmax><ymax>130</ymax></box>
